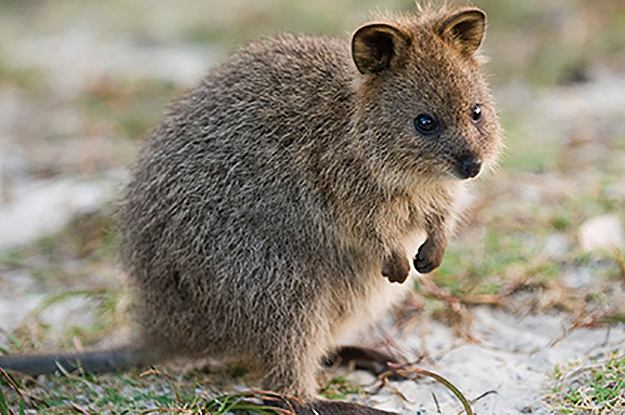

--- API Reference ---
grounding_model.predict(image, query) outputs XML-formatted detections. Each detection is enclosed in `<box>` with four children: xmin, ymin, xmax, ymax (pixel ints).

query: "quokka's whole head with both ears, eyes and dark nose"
<box><xmin>352</xmin><ymin>8</ymin><xmax>501</xmax><ymax>186</ymax></box>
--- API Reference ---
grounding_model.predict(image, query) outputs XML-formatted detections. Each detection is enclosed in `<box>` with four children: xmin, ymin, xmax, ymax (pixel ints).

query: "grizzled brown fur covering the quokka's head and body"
<box><xmin>0</xmin><ymin>3</ymin><xmax>500</xmax><ymax>413</ymax></box>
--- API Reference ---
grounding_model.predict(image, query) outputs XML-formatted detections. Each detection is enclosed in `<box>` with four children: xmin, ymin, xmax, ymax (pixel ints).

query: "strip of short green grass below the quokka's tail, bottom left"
<box><xmin>0</xmin><ymin>370</ymin><xmax>294</xmax><ymax>414</ymax></box>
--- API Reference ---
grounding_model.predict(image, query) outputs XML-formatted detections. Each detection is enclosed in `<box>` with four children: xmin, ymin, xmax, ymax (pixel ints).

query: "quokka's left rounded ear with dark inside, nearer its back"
<box><xmin>352</xmin><ymin>23</ymin><xmax>410</xmax><ymax>74</ymax></box>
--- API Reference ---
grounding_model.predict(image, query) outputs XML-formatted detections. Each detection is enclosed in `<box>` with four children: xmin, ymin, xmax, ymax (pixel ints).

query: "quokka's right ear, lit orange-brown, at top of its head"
<box><xmin>438</xmin><ymin>9</ymin><xmax>486</xmax><ymax>56</ymax></box>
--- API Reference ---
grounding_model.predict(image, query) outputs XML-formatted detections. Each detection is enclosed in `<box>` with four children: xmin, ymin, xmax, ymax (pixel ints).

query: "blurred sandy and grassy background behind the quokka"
<box><xmin>0</xmin><ymin>0</ymin><xmax>625</xmax><ymax>410</ymax></box>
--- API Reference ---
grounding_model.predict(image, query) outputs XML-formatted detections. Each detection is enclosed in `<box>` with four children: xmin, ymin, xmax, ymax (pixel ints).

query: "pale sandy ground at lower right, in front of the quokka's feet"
<box><xmin>354</xmin><ymin>307</ymin><xmax>625</xmax><ymax>415</ymax></box>
